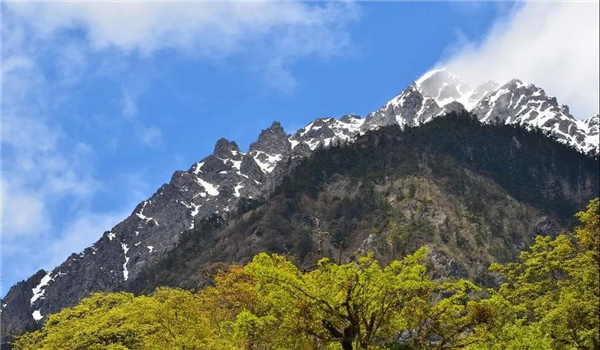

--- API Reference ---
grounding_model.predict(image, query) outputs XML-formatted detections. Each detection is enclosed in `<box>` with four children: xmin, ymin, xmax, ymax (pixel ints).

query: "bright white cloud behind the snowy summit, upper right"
<box><xmin>438</xmin><ymin>2</ymin><xmax>600</xmax><ymax>119</ymax></box>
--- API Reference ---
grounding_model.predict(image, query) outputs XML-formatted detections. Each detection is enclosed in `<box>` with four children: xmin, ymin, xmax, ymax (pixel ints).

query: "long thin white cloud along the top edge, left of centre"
<box><xmin>6</xmin><ymin>1</ymin><xmax>358</xmax><ymax>90</ymax></box>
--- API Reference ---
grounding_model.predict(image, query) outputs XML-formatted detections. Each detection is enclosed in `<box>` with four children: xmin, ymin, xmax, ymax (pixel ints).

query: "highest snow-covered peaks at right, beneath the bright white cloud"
<box><xmin>363</xmin><ymin>69</ymin><xmax>599</xmax><ymax>154</ymax></box>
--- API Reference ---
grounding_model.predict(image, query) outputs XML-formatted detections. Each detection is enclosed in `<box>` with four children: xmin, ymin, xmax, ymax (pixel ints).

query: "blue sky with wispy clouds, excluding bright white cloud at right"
<box><xmin>1</xmin><ymin>2</ymin><xmax>598</xmax><ymax>295</ymax></box>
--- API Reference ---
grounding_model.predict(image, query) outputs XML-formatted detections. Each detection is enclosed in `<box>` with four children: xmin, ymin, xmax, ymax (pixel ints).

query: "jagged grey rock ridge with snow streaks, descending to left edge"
<box><xmin>0</xmin><ymin>115</ymin><xmax>372</xmax><ymax>340</ymax></box>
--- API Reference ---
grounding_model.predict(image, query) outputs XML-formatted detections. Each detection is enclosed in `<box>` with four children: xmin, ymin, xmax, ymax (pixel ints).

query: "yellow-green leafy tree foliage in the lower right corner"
<box><xmin>478</xmin><ymin>198</ymin><xmax>600</xmax><ymax>349</ymax></box>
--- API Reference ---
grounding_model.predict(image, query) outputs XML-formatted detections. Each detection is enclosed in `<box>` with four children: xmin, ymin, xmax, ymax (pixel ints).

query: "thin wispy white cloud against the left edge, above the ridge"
<box><xmin>0</xmin><ymin>49</ymin><xmax>98</xmax><ymax>240</ymax></box>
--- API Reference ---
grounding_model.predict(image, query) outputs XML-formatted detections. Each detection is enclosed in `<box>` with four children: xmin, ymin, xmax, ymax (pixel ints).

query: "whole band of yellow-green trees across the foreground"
<box><xmin>15</xmin><ymin>199</ymin><xmax>600</xmax><ymax>350</ymax></box>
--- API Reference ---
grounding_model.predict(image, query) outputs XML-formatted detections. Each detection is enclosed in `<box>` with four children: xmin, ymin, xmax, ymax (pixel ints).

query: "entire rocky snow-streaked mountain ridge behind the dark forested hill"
<box><xmin>0</xmin><ymin>73</ymin><xmax>598</xmax><ymax>341</ymax></box>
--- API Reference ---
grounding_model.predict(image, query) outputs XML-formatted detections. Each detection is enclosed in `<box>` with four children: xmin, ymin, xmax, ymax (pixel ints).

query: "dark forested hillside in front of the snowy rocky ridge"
<box><xmin>134</xmin><ymin>113</ymin><xmax>598</xmax><ymax>292</ymax></box>
